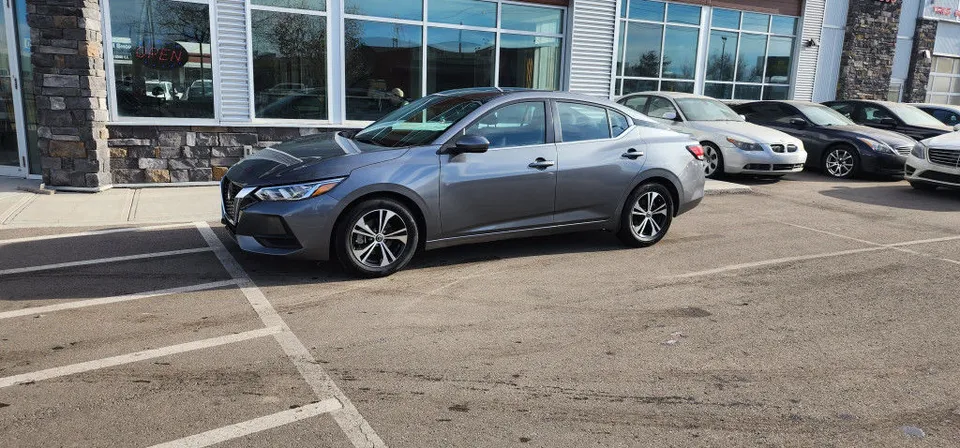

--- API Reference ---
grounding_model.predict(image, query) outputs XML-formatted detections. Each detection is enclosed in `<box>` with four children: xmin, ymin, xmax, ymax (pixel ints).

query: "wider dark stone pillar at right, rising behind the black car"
<box><xmin>837</xmin><ymin>0</ymin><xmax>901</xmax><ymax>100</ymax></box>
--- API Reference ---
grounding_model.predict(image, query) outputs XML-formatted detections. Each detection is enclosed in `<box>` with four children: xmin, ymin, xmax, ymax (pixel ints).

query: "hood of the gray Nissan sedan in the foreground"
<box><xmin>226</xmin><ymin>132</ymin><xmax>408</xmax><ymax>187</ymax></box>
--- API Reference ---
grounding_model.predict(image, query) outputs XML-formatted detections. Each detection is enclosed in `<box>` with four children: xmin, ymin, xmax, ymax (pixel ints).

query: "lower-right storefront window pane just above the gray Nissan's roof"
<box><xmin>499</xmin><ymin>34</ymin><xmax>560</xmax><ymax>90</ymax></box>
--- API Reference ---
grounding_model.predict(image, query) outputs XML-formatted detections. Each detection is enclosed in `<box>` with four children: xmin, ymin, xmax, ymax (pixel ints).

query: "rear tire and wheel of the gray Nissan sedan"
<box><xmin>617</xmin><ymin>183</ymin><xmax>676</xmax><ymax>247</ymax></box>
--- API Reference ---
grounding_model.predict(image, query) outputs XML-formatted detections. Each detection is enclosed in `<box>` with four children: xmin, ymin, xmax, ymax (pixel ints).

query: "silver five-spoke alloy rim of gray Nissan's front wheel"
<box><xmin>350</xmin><ymin>209</ymin><xmax>408</xmax><ymax>268</ymax></box>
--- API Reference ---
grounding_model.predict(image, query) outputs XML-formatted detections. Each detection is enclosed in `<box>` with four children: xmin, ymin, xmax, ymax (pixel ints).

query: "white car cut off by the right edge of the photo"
<box><xmin>904</xmin><ymin>133</ymin><xmax>960</xmax><ymax>190</ymax></box>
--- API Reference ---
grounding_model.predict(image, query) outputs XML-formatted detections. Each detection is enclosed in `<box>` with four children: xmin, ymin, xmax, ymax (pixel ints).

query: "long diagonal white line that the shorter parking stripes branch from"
<box><xmin>196</xmin><ymin>222</ymin><xmax>387</xmax><ymax>448</ymax></box>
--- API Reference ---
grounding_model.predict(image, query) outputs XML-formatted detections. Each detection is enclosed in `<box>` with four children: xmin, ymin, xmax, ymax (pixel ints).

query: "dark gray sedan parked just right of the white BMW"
<box><xmin>733</xmin><ymin>101</ymin><xmax>917</xmax><ymax>179</ymax></box>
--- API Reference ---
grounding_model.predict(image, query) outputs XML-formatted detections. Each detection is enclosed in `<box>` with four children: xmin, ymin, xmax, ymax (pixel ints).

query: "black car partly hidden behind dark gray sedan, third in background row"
<box><xmin>823</xmin><ymin>100</ymin><xmax>953</xmax><ymax>141</ymax></box>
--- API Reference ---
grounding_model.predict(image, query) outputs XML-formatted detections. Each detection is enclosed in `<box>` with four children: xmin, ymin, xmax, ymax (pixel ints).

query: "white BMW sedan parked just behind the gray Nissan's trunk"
<box><xmin>617</xmin><ymin>92</ymin><xmax>807</xmax><ymax>178</ymax></box>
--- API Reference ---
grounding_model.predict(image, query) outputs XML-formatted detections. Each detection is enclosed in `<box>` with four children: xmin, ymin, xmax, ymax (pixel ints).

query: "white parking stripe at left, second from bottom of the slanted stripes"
<box><xmin>0</xmin><ymin>327</ymin><xmax>284</xmax><ymax>388</ymax></box>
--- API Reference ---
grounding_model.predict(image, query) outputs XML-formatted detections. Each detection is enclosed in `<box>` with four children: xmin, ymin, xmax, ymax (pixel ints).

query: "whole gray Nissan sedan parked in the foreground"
<box><xmin>221</xmin><ymin>88</ymin><xmax>704</xmax><ymax>277</ymax></box>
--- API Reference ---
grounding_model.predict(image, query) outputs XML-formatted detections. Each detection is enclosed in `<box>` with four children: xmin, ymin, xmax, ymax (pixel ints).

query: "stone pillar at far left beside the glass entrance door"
<box><xmin>27</xmin><ymin>0</ymin><xmax>111</xmax><ymax>190</ymax></box>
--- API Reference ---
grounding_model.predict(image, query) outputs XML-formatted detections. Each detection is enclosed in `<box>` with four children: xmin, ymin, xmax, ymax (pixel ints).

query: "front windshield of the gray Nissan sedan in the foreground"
<box><xmin>354</xmin><ymin>95</ymin><xmax>486</xmax><ymax>147</ymax></box>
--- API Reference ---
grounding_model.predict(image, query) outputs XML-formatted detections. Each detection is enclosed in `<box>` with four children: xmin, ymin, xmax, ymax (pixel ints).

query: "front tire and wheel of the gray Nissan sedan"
<box><xmin>333</xmin><ymin>198</ymin><xmax>420</xmax><ymax>278</ymax></box>
